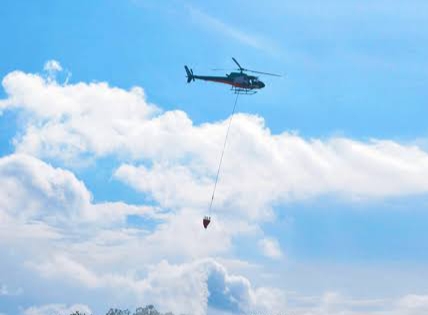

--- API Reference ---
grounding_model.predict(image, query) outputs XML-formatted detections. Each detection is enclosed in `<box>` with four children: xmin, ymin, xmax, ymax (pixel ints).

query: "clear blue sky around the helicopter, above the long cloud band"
<box><xmin>5</xmin><ymin>1</ymin><xmax>428</xmax><ymax>139</ymax></box>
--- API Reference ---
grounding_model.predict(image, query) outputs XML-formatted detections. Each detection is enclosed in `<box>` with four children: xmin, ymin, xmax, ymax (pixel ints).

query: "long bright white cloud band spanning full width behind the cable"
<box><xmin>0</xmin><ymin>71</ymin><xmax>428</xmax><ymax>225</ymax></box>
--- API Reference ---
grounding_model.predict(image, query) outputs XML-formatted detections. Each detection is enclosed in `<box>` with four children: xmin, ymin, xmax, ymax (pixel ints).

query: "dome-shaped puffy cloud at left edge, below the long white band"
<box><xmin>0</xmin><ymin>155</ymin><xmax>91</xmax><ymax>224</ymax></box>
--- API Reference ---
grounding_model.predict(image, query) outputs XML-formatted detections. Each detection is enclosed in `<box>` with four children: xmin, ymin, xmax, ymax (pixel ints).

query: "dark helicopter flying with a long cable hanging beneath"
<box><xmin>184</xmin><ymin>57</ymin><xmax>280</xmax><ymax>94</ymax></box>
